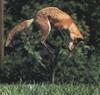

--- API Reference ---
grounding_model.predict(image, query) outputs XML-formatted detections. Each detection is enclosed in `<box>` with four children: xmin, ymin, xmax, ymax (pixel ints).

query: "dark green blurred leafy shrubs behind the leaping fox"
<box><xmin>0</xmin><ymin>0</ymin><xmax>100</xmax><ymax>83</ymax></box>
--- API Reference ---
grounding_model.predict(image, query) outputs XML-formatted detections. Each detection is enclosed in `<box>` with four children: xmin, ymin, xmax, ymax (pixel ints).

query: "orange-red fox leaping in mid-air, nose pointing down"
<box><xmin>6</xmin><ymin>7</ymin><xmax>84</xmax><ymax>50</ymax></box>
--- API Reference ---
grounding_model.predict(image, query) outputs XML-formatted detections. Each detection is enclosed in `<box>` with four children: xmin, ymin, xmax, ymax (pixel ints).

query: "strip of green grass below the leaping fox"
<box><xmin>0</xmin><ymin>84</ymin><xmax>100</xmax><ymax>95</ymax></box>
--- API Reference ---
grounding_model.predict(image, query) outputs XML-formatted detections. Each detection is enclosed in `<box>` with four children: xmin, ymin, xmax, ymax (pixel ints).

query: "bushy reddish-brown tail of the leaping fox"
<box><xmin>5</xmin><ymin>18</ymin><xmax>34</xmax><ymax>47</ymax></box>
